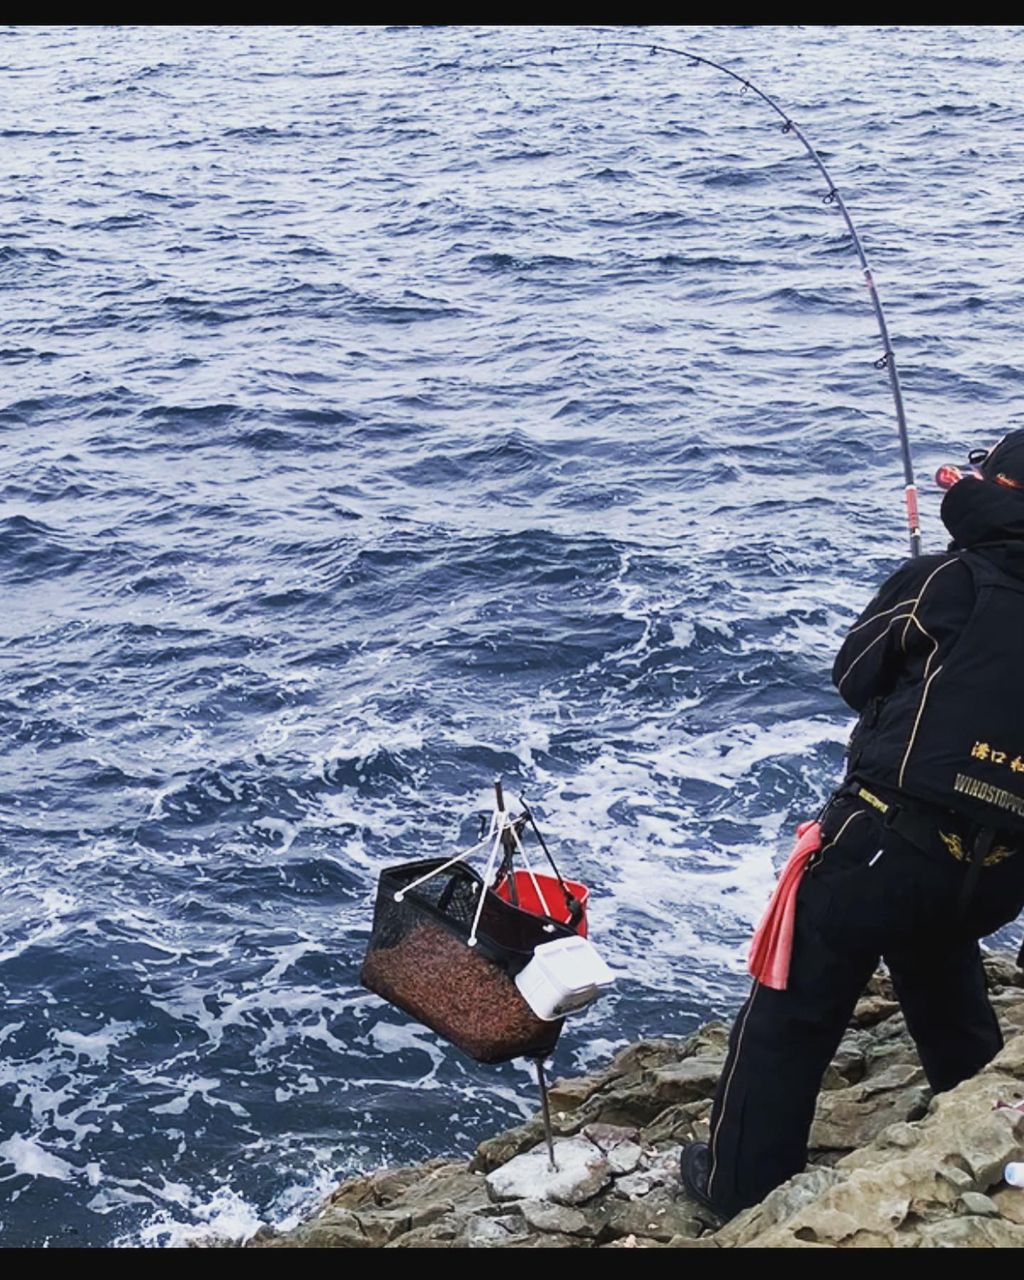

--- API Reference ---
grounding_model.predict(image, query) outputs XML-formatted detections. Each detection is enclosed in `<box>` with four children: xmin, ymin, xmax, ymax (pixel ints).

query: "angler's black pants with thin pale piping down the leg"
<box><xmin>708</xmin><ymin>797</ymin><xmax>1024</xmax><ymax>1217</ymax></box>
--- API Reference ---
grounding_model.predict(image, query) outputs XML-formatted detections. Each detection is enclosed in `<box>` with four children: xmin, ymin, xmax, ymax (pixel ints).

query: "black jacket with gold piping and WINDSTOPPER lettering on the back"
<box><xmin>832</xmin><ymin>479</ymin><xmax>1024</xmax><ymax>833</ymax></box>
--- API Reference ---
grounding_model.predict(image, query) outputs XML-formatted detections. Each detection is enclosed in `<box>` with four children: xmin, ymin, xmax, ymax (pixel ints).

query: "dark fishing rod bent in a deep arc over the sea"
<box><xmin>483</xmin><ymin>40</ymin><xmax>920</xmax><ymax>556</ymax></box>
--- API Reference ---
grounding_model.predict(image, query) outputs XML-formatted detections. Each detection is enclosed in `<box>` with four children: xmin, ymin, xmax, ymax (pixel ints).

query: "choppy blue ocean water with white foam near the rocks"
<box><xmin>0</xmin><ymin>27</ymin><xmax>1024</xmax><ymax>1245</ymax></box>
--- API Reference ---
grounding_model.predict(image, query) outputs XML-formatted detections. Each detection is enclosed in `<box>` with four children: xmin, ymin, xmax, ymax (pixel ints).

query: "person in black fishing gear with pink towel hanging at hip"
<box><xmin>682</xmin><ymin>430</ymin><xmax>1024</xmax><ymax>1216</ymax></box>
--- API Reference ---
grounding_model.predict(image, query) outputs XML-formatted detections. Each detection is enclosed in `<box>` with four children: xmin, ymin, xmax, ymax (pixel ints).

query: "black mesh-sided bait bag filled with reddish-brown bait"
<box><xmin>361</xmin><ymin>858</ymin><xmax>573</xmax><ymax>1062</ymax></box>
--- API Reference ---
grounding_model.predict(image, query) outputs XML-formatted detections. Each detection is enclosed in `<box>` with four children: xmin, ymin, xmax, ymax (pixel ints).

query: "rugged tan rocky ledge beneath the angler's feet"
<box><xmin>246</xmin><ymin>956</ymin><xmax>1024</xmax><ymax>1249</ymax></box>
